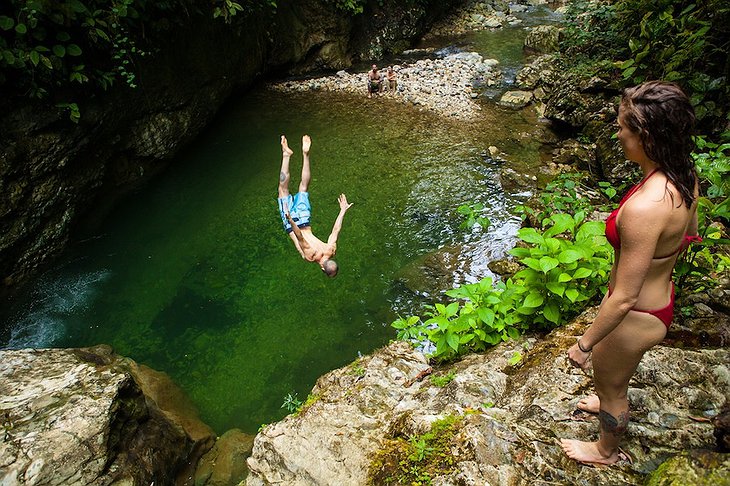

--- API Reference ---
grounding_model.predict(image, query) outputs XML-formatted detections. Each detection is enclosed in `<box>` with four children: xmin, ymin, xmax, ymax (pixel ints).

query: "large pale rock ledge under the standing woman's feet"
<box><xmin>246</xmin><ymin>309</ymin><xmax>730</xmax><ymax>486</ymax></box>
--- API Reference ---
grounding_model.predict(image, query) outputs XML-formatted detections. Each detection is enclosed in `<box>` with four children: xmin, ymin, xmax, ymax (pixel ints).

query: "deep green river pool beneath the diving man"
<box><xmin>0</xmin><ymin>6</ymin><xmax>560</xmax><ymax>433</ymax></box>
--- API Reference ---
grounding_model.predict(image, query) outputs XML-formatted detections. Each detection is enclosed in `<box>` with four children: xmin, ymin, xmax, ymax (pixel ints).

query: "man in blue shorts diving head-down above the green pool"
<box><xmin>278</xmin><ymin>135</ymin><xmax>352</xmax><ymax>278</ymax></box>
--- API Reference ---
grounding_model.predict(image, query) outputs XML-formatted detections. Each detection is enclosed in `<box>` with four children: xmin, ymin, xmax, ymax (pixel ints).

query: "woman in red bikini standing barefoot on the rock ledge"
<box><xmin>561</xmin><ymin>81</ymin><xmax>699</xmax><ymax>464</ymax></box>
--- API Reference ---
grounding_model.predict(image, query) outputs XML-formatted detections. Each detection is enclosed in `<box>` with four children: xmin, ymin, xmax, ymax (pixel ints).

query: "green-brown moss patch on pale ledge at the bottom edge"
<box><xmin>367</xmin><ymin>415</ymin><xmax>463</xmax><ymax>486</ymax></box>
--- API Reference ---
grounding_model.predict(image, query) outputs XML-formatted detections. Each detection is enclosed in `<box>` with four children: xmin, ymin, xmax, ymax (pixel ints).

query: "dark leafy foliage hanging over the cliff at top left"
<box><xmin>0</xmin><ymin>0</ymin><xmax>276</xmax><ymax>121</ymax></box>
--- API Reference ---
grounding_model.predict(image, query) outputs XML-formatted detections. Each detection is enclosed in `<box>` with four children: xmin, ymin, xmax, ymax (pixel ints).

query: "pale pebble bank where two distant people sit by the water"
<box><xmin>270</xmin><ymin>52</ymin><xmax>501</xmax><ymax>120</ymax></box>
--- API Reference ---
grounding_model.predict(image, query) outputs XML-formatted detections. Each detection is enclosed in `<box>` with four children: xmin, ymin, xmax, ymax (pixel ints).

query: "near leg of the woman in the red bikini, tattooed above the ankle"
<box><xmin>561</xmin><ymin>311</ymin><xmax>667</xmax><ymax>464</ymax></box>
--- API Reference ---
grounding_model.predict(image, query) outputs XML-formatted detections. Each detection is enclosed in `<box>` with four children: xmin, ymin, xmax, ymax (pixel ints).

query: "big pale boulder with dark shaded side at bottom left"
<box><xmin>0</xmin><ymin>346</ymin><xmax>214</xmax><ymax>486</ymax></box>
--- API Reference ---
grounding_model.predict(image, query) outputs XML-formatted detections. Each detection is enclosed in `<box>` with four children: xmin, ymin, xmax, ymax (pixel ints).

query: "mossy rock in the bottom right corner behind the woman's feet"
<box><xmin>646</xmin><ymin>451</ymin><xmax>730</xmax><ymax>486</ymax></box>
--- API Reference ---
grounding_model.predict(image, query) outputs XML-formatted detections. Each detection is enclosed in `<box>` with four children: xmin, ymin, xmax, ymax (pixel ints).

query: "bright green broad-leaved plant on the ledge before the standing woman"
<box><xmin>393</xmin><ymin>213</ymin><xmax>613</xmax><ymax>360</ymax></box>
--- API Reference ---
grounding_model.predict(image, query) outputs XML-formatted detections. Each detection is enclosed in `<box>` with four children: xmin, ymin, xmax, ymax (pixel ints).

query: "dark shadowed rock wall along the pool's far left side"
<box><xmin>0</xmin><ymin>0</ymin><xmax>463</xmax><ymax>291</ymax></box>
